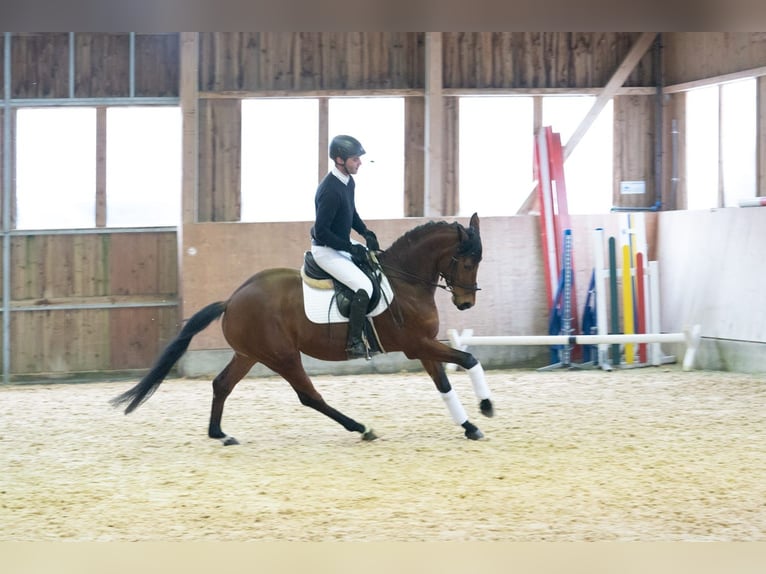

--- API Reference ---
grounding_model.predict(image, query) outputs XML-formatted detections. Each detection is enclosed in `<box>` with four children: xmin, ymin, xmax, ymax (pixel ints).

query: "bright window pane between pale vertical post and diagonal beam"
<box><xmin>458</xmin><ymin>97</ymin><xmax>534</xmax><ymax>216</ymax></box>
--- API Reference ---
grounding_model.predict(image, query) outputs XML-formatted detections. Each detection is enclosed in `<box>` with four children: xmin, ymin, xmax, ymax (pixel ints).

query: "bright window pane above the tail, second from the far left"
<box><xmin>106</xmin><ymin>107</ymin><xmax>181</xmax><ymax>227</ymax></box>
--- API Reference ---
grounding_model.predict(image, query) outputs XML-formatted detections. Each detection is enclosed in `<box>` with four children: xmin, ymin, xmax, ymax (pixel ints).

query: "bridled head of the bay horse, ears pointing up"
<box><xmin>441</xmin><ymin>213</ymin><xmax>481</xmax><ymax>311</ymax></box>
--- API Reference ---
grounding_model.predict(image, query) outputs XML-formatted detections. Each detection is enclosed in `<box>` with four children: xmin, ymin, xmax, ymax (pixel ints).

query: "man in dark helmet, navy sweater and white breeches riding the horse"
<box><xmin>311</xmin><ymin>135</ymin><xmax>380</xmax><ymax>359</ymax></box>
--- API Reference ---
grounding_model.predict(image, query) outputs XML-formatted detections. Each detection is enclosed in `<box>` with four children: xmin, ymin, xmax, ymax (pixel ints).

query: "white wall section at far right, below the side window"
<box><xmin>658</xmin><ymin>207</ymin><xmax>766</xmax><ymax>372</ymax></box>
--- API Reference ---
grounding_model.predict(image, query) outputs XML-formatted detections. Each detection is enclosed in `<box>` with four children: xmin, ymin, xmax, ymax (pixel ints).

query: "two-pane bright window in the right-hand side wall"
<box><xmin>686</xmin><ymin>79</ymin><xmax>757</xmax><ymax>209</ymax></box>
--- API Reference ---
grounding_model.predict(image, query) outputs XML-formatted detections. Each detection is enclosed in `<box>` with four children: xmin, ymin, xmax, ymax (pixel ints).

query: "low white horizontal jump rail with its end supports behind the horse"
<box><xmin>447</xmin><ymin>325</ymin><xmax>701</xmax><ymax>371</ymax></box>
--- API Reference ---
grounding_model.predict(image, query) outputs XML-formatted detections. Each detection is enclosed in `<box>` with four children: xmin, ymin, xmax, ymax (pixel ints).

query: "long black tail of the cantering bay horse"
<box><xmin>109</xmin><ymin>301</ymin><xmax>226</xmax><ymax>414</ymax></box>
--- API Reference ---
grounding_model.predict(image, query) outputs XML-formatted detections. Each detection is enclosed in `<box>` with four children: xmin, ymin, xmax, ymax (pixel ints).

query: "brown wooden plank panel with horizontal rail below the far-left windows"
<box><xmin>4</xmin><ymin>231</ymin><xmax>179</xmax><ymax>378</ymax></box>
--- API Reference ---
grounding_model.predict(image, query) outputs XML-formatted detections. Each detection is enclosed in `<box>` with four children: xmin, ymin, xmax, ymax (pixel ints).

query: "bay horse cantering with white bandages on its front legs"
<box><xmin>110</xmin><ymin>213</ymin><xmax>494</xmax><ymax>445</ymax></box>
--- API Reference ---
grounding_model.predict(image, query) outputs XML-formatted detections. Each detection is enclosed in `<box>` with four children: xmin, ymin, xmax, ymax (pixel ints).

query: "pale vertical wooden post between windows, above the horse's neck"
<box><xmin>423</xmin><ymin>32</ymin><xmax>444</xmax><ymax>217</ymax></box>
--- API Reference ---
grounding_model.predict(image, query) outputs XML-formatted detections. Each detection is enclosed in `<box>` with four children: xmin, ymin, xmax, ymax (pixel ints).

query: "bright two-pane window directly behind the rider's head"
<box><xmin>241</xmin><ymin>97</ymin><xmax>404</xmax><ymax>221</ymax></box>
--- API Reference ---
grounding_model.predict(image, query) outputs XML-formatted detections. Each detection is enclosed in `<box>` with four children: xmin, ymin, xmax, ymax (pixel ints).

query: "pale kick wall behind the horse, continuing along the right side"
<box><xmin>179</xmin><ymin>208</ymin><xmax>766</xmax><ymax>377</ymax></box>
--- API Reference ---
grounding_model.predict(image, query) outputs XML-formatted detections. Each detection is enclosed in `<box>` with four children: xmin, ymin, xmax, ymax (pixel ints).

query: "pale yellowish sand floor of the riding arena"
<box><xmin>0</xmin><ymin>366</ymin><xmax>766</xmax><ymax>541</ymax></box>
